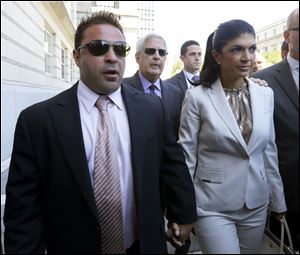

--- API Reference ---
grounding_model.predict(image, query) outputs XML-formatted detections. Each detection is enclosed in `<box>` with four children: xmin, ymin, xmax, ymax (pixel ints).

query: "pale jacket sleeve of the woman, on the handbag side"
<box><xmin>263</xmin><ymin>90</ymin><xmax>287</xmax><ymax>213</ymax></box>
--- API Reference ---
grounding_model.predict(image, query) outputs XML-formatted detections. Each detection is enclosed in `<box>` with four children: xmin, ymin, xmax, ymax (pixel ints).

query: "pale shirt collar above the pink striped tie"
<box><xmin>77</xmin><ymin>80</ymin><xmax>123</xmax><ymax>113</ymax></box>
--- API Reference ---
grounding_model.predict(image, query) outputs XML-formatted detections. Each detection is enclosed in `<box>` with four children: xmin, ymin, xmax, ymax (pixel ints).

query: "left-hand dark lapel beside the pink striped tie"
<box><xmin>49</xmin><ymin>84</ymin><xmax>98</xmax><ymax>219</ymax></box>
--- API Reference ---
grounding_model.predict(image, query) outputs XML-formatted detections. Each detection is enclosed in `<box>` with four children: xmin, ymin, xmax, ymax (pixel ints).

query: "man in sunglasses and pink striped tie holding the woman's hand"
<box><xmin>4</xmin><ymin>12</ymin><xmax>197</xmax><ymax>254</ymax></box>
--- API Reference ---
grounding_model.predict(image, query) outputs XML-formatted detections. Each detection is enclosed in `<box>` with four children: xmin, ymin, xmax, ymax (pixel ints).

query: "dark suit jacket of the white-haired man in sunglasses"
<box><xmin>123</xmin><ymin>72</ymin><xmax>184</xmax><ymax>137</ymax></box>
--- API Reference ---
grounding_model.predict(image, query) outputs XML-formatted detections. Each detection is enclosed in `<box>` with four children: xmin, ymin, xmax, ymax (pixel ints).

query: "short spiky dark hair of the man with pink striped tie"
<box><xmin>74</xmin><ymin>11</ymin><xmax>124</xmax><ymax>49</ymax></box>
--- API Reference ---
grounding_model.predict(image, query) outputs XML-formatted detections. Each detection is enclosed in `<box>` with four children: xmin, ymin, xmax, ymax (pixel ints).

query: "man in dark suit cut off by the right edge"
<box><xmin>253</xmin><ymin>8</ymin><xmax>299</xmax><ymax>249</ymax></box>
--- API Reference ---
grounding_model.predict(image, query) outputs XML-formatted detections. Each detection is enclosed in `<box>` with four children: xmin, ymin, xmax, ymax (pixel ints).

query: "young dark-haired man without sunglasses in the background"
<box><xmin>166</xmin><ymin>40</ymin><xmax>202</xmax><ymax>98</ymax></box>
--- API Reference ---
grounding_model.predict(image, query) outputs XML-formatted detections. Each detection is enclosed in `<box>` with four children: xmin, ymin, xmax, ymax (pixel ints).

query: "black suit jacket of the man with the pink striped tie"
<box><xmin>4</xmin><ymin>82</ymin><xmax>196</xmax><ymax>254</ymax></box>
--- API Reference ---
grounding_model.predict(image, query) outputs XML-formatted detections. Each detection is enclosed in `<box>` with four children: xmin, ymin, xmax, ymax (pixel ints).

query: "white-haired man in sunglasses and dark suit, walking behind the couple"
<box><xmin>123</xmin><ymin>33</ymin><xmax>183</xmax><ymax>137</ymax></box>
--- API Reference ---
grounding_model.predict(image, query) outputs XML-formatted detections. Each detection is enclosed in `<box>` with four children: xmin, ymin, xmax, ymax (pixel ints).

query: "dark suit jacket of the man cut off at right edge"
<box><xmin>253</xmin><ymin>60</ymin><xmax>299</xmax><ymax>214</ymax></box>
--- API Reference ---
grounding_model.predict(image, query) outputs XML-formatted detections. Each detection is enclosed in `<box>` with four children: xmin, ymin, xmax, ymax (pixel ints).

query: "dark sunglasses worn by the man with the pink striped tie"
<box><xmin>77</xmin><ymin>40</ymin><xmax>130</xmax><ymax>57</ymax></box>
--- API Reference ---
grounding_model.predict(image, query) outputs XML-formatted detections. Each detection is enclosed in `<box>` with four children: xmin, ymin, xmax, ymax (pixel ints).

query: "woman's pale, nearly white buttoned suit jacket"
<box><xmin>179</xmin><ymin>79</ymin><xmax>286</xmax><ymax>212</ymax></box>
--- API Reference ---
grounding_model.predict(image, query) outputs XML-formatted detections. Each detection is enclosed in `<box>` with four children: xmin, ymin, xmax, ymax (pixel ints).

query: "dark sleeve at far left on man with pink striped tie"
<box><xmin>4</xmin><ymin>112</ymin><xmax>46</xmax><ymax>254</ymax></box>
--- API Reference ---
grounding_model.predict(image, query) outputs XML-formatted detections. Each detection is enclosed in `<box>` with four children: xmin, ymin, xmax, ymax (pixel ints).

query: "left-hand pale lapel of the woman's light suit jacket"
<box><xmin>208</xmin><ymin>79</ymin><xmax>247</xmax><ymax>152</ymax></box>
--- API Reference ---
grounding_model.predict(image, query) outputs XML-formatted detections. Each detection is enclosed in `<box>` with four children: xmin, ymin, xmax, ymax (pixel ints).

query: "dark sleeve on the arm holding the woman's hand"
<box><xmin>161</xmin><ymin>98</ymin><xmax>197</xmax><ymax>224</ymax></box>
